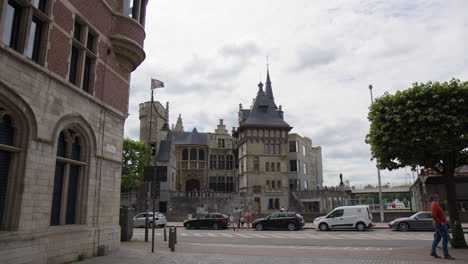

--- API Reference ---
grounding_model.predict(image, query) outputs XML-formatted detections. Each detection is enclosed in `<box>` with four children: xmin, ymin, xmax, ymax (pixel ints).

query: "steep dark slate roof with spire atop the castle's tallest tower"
<box><xmin>241</xmin><ymin>71</ymin><xmax>289</xmax><ymax>127</ymax></box>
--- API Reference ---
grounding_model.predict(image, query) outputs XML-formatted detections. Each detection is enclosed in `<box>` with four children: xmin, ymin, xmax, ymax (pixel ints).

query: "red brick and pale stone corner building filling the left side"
<box><xmin>0</xmin><ymin>0</ymin><xmax>147</xmax><ymax>263</ymax></box>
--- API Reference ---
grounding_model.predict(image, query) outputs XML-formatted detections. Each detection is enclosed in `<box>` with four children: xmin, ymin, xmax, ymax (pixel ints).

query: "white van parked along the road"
<box><xmin>314</xmin><ymin>205</ymin><xmax>374</xmax><ymax>231</ymax></box>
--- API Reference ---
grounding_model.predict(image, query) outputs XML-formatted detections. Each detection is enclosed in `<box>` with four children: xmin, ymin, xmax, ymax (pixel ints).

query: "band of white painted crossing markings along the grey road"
<box><xmin>134</xmin><ymin>229</ymin><xmax>434</xmax><ymax>241</ymax></box>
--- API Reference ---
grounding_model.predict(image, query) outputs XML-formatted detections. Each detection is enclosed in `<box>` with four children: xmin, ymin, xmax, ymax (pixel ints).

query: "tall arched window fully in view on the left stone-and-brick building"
<box><xmin>50</xmin><ymin>129</ymin><xmax>86</xmax><ymax>226</ymax></box>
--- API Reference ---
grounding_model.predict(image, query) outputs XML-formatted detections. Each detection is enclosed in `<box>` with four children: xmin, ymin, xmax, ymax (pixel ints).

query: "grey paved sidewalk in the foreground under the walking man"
<box><xmin>80</xmin><ymin>242</ymin><xmax>468</xmax><ymax>264</ymax></box>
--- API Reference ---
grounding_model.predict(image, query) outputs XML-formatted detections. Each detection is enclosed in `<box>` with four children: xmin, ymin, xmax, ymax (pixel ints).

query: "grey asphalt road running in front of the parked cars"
<box><xmin>133</xmin><ymin>228</ymin><xmax>454</xmax><ymax>250</ymax></box>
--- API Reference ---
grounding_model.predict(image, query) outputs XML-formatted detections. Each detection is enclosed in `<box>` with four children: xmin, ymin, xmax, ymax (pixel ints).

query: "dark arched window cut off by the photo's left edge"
<box><xmin>0</xmin><ymin>113</ymin><xmax>16</xmax><ymax>226</ymax></box>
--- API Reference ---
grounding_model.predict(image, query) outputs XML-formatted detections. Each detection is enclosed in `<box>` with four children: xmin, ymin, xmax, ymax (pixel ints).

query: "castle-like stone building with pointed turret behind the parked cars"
<box><xmin>139</xmin><ymin>70</ymin><xmax>323</xmax><ymax>212</ymax></box>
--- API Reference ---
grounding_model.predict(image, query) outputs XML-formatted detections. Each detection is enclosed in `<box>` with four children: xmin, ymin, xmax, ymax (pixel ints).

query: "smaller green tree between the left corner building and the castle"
<box><xmin>120</xmin><ymin>138</ymin><xmax>149</xmax><ymax>192</ymax></box>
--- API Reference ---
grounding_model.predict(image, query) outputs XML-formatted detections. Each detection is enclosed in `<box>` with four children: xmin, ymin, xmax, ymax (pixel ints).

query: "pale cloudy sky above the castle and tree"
<box><xmin>124</xmin><ymin>0</ymin><xmax>468</xmax><ymax>187</ymax></box>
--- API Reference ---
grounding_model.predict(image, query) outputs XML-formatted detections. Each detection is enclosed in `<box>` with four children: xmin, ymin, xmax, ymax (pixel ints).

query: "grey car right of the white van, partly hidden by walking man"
<box><xmin>388</xmin><ymin>211</ymin><xmax>450</xmax><ymax>231</ymax></box>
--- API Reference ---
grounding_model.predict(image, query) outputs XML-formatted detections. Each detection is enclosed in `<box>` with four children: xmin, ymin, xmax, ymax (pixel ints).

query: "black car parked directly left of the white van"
<box><xmin>252</xmin><ymin>212</ymin><xmax>304</xmax><ymax>231</ymax></box>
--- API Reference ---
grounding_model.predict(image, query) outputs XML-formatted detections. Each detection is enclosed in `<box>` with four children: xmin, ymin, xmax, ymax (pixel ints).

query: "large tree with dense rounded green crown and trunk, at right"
<box><xmin>366</xmin><ymin>79</ymin><xmax>468</xmax><ymax>247</ymax></box>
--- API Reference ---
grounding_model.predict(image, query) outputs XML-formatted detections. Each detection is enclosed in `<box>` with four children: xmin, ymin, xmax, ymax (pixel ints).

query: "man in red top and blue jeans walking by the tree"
<box><xmin>431</xmin><ymin>194</ymin><xmax>455</xmax><ymax>259</ymax></box>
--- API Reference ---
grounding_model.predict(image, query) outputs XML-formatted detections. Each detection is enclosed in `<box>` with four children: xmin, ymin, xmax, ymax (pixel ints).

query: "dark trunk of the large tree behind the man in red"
<box><xmin>444</xmin><ymin>168</ymin><xmax>467</xmax><ymax>248</ymax></box>
